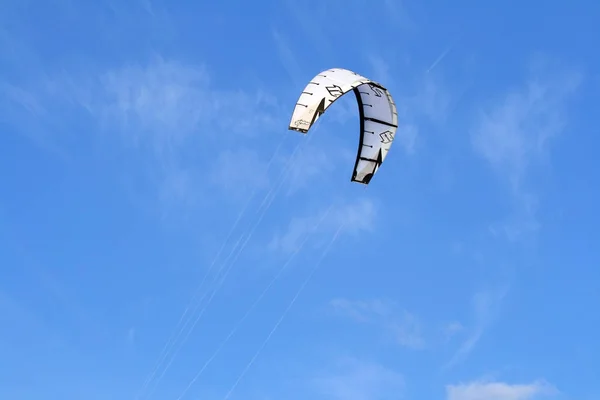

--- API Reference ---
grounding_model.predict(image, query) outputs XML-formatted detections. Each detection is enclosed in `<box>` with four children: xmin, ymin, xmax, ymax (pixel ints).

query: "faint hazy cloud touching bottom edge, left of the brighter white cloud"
<box><xmin>313</xmin><ymin>359</ymin><xmax>404</xmax><ymax>400</ymax></box>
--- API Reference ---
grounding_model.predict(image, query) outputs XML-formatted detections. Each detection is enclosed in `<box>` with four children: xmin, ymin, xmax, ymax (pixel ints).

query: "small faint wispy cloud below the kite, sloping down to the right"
<box><xmin>330</xmin><ymin>298</ymin><xmax>425</xmax><ymax>350</ymax></box>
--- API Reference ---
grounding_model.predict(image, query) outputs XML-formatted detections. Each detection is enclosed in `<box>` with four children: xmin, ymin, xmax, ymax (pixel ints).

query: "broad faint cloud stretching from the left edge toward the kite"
<box><xmin>0</xmin><ymin>57</ymin><xmax>283</xmax><ymax>214</ymax></box>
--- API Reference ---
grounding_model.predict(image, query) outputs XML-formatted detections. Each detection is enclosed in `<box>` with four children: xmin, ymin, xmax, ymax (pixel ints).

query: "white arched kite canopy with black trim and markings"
<box><xmin>289</xmin><ymin>68</ymin><xmax>398</xmax><ymax>185</ymax></box>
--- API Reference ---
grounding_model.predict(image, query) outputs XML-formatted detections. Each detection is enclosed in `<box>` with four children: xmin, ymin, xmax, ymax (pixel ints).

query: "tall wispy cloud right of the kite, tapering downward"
<box><xmin>471</xmin><ymin>59</ymin><xmax>583</xmax><ymax>239</ymax></box>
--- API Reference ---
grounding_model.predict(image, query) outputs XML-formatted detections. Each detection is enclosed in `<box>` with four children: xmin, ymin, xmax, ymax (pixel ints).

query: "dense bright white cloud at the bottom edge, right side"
<box><xmin>446</xmin><ymin>381</ymin><xmax>557</xmax><ymax>400</ymax></box>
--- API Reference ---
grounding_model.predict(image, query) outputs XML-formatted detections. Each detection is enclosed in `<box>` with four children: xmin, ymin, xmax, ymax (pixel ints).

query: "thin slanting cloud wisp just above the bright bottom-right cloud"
<box><xmin>445</xmin><ymin>287</ymin><xmax>508</xmax><ymax>368</ymax></box>
